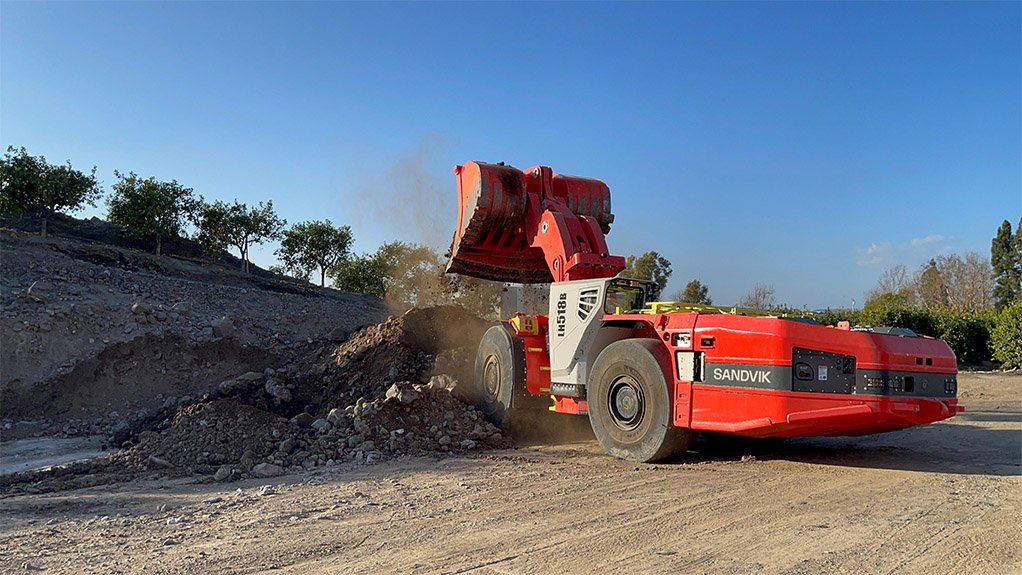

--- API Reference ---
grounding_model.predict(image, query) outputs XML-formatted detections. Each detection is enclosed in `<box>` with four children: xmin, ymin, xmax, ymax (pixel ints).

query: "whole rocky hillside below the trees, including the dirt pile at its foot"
<box><xmin>0</xmin><ymin>222</ymin><xmax>509</xmax><ymax>492</ymax></box>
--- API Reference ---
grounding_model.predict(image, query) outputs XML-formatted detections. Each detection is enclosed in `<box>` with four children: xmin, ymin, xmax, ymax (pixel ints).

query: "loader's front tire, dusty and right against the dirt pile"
<box><xmin>471</xmin><ymin>325</ymin><xmax>525</xmax><ymax>426</ymax></box>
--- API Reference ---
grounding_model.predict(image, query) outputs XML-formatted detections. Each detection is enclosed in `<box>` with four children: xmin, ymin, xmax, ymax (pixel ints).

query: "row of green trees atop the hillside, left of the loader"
<box><xmin>0</xmin><ymin>147</ymin><xmax>504</xmax><ymax>317</ymax></box>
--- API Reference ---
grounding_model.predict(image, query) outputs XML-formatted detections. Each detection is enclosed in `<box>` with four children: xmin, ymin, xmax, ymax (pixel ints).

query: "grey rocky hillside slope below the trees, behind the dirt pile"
<box><xmin>0</xmin><ymin>231</ymin><xmax>387</xmax><ymax>438</ymax></box>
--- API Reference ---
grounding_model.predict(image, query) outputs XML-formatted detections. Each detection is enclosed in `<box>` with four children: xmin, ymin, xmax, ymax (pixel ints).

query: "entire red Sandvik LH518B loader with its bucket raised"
<box><xmin>448</xmin><ymin>161</ymin><xmax>964</xmax><ymax>462</ymax></box>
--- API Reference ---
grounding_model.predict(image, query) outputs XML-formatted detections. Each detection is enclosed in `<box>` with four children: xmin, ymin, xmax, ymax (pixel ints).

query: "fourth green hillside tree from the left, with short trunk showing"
<box><xmin>277</xmin><ymin>220</ymin><xmax>352</xmax><ymax>286</ymax></box>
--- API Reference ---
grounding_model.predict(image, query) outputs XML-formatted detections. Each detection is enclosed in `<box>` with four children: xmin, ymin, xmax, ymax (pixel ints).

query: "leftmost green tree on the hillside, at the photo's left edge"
<box><xmin>0</xmin><ymin>146</ymin><xmax>102</xmax><ymax>238</ymax></box>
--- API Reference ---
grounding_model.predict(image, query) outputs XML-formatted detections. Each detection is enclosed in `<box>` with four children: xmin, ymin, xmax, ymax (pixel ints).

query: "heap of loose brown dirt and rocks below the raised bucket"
<box><xmin>105</xmin><ymin>306</ymin><xmax>509</xmax><ymax>480</ymax></box>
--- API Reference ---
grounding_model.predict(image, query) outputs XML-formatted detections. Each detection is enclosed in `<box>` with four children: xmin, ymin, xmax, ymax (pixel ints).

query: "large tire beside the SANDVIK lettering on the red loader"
<box><xmin>587</xmin><ymin>339</ymin><xmax>696</xmax><ymax>462</ymax></box>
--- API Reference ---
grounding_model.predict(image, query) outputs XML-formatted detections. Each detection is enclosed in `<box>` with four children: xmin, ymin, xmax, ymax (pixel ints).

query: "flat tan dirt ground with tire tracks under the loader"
<box><xmin>0</xmin><ymin>373</ymin><xmax>1022</xmax><ymax>575</ymax></box>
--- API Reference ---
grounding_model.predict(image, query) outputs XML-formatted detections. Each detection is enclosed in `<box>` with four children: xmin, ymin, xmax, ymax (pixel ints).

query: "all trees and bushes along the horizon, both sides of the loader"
<box><xmin>0</xmin><ymin>147</ymin><xmax>1022</xmax><ymax>367</ymax></box>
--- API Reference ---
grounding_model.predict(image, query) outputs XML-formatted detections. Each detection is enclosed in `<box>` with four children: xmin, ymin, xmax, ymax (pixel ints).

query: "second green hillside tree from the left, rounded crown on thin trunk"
<box><xmin>106</xmin><ymin>172</ymin><xmax>198</xmax><ymax>255</ymax></box>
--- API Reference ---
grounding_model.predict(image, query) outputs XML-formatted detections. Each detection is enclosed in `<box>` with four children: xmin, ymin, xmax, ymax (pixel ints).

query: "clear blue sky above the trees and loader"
<box><xmin>0</xmin><ymin>1</ymin><xmax>1022</xmax><ymax>307</ymax></box>
